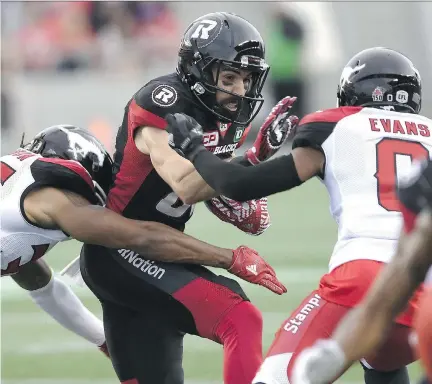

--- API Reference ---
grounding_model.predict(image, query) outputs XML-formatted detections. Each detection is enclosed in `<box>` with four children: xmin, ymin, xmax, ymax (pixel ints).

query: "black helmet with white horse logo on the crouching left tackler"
<box><xmin>21</xmin><ymin>125</ymin><xmax>113</xmax><ymax>205</ymax></box>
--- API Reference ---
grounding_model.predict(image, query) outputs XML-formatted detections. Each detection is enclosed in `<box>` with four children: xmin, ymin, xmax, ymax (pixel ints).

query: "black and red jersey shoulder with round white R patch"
<box><xmin>128</xmin><ymin>74</ymin><xmax>193</xmax><ymax>129</ymax></box>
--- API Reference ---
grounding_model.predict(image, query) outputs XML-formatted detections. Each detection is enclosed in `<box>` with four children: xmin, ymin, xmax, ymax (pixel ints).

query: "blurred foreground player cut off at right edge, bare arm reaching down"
<box><xmin>293</xmin><ymin>160</ymin><xmax>432</xmax><ymax>384</ymax></box>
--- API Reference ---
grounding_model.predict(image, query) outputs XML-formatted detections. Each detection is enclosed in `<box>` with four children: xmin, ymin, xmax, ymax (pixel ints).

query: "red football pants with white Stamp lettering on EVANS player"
<box><xmin>253</xmin><ymin>260</ymin><xmax>420</xmax><ymax>384</ymax></box>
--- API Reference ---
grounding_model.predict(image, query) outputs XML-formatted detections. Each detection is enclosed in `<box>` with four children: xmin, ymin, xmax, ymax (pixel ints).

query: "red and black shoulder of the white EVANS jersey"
<box><xmin>293</xmin><ymin>107</ymin><xmax>362</xmax><ymax>149</ymax></box>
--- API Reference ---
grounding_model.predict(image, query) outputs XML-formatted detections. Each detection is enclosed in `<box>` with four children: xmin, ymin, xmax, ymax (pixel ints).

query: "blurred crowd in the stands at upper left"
<box><xmin>2</xmin><ymin>1</ymin><xmax>179</xmax><ymax>71</ymax></box>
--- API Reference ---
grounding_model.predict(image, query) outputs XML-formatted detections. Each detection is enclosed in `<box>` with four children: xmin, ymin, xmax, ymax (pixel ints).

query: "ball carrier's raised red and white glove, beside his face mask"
<box><xmin>244</xmin><ymin>96</ymin><xmax>299</xmax><ymax>165</ymax></box>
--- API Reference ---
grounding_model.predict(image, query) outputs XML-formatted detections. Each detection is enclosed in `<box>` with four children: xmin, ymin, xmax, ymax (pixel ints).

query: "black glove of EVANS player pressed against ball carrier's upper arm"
<box><xmin>165</xmin><ymin>113</ymin><xmax>205</xmax><ymax>161</ymax></box>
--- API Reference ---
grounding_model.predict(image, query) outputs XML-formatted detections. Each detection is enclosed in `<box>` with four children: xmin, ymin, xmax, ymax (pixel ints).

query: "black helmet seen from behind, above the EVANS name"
<box><xmin>337</xmin><ymin>47</ymin><xmax>421</xmax><ymax>113</ymax></box>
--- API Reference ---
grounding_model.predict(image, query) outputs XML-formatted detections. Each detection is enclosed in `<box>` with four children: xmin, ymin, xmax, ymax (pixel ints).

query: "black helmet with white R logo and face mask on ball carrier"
<box><xmin>177</xmin><ymin>12</ymin><xmax>269</xmax><ymax>125</ymax></box>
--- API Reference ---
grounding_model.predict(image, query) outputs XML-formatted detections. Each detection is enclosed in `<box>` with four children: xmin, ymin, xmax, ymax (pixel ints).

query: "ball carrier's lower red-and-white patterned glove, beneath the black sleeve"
<box><xmin>204</xmin><ymin>196</ymin><xmax>270</xmax><ymax>236</ymax></box>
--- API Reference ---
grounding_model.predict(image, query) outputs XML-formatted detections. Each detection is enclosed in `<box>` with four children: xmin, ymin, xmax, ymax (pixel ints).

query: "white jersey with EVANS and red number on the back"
<box><xmin>293</xmin><ymin>107</ymin><xmax>432</xmax><ymax>271</ymax></box>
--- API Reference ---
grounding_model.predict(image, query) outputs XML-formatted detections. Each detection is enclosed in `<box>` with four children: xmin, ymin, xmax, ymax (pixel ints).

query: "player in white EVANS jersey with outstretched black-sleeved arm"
<box><xmin>171</xmin><ymin>47</ymin><xmax>432</xmax><ymax>384</ymax></box>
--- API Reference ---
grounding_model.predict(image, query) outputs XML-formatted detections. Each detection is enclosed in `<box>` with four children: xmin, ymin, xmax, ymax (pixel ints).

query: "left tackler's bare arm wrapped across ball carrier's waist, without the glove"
<box><xmin>24</xmin><ymin>188</ymin><xmax>233</xmax><ymax>269</ymax></box>
